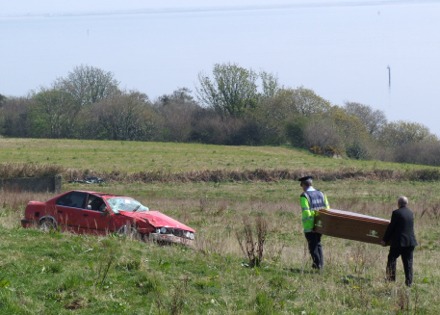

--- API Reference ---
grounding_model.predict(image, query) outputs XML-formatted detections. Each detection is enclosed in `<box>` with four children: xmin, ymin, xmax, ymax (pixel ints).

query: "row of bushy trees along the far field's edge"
<box><xmin>0</xmin><ymin>63</ymin><xmax>440</xmax><ymax>165</ymax></box>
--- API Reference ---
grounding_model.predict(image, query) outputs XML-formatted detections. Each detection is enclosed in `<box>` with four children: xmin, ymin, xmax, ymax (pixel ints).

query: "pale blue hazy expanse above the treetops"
<box><xmin>0</xmin><ymin>0</ymin><xmax>440</xmax><ymax>136</ymax></box>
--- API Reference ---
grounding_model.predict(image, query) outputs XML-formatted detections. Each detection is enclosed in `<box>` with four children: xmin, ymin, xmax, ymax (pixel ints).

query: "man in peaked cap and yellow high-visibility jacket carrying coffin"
<box><xmin>299</xmin><ymin>176</ymin><xmax>330</xmax><ymax>270</ymax></box>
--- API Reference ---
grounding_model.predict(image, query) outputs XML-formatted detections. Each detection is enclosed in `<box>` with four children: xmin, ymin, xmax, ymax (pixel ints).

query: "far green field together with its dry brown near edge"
<box><xmin>0</xmin><ymin>138</ymin><xmax>440</xmax><ymax>183</ymax></box>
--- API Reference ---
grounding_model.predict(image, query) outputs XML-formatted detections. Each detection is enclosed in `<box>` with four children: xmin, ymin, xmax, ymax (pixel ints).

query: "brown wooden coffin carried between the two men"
<box><xmin>314</xmin><ymin>209</ymin><xmax>390</xmax><ymax>244</ymax></box>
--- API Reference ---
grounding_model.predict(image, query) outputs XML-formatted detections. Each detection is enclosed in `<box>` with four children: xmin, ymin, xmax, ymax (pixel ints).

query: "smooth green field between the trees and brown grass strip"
<box><xmin>0</xmin><ymin>138</ymin><xmax>434</xmax><ymax>173</ymax></box>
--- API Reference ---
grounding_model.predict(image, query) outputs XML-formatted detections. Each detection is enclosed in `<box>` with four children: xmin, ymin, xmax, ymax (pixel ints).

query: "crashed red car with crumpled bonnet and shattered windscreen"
<box><xmin>21</xmin><ymin>190</ymin><xmax>195</xmax><ymax>245</ymax></box>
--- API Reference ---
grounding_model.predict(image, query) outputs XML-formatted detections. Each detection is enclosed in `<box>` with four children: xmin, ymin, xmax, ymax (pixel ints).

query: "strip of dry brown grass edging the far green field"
<box><xmin>5</xmin><ymin>163</ymin><xmax>440</xmax><ymax>183</ymax></box>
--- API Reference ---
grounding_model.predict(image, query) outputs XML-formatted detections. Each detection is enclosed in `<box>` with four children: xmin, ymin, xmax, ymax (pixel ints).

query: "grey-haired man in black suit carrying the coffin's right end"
<box><xmin>382</xmin><ymin>196</ymin><xmax>417</xmax><ymax>287</ymax></box>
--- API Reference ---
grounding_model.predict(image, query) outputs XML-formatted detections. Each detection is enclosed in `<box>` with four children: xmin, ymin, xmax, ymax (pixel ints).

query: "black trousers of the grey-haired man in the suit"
<box><xmin>387</xmin><ymin>246</ymin><xmax>414</xmax><ymax>287</ymax></box>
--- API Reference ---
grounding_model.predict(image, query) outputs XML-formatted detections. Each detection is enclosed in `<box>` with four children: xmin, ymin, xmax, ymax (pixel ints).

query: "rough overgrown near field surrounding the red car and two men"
<box><xmin>0</xmin><ymin>180</ymin><xmax>440</xmax><ymax>314</ymax></box>
